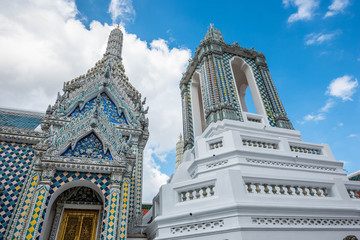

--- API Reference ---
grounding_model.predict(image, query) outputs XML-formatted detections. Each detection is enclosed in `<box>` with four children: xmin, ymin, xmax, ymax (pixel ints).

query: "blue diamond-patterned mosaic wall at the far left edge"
<box><xmin>0</xmin><ymin>142</ymin><xmax>34</xmax><ymax>239</ymax></box>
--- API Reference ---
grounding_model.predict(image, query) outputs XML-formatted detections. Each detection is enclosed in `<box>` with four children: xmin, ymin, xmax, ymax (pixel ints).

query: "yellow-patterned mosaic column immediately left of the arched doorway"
<box><xmin>24</xmin><ymin>168</ymin><xmax>55</xmax><ymax>240</ymax></box>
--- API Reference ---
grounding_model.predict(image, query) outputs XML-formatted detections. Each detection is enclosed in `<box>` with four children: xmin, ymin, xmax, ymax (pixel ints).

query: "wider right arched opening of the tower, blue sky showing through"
<box><xmin>231</xmin><ymin>57</ymin><xmax>266</xmax><ymax>116</ymax></box>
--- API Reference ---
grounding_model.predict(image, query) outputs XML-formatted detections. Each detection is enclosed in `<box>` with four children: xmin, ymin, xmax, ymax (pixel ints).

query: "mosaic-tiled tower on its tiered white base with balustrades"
<box><xmin>143</xmin><ymin>26</ymin><xmax>360</xmax><ymax>240</ymax></box>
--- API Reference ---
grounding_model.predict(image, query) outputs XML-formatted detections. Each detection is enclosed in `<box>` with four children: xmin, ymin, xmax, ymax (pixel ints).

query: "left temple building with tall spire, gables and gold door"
<box><xmin>0</xmin><ymin>28</ymin><xmax>149</xmax><ymax>240</ymax></box>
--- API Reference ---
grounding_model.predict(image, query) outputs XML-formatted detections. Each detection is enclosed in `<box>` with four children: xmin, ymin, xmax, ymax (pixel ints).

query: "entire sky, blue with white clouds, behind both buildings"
<box><xmin>0</xmin><ymin>0</ymin><xmax>360</xmax><ymax>201</ymax></box>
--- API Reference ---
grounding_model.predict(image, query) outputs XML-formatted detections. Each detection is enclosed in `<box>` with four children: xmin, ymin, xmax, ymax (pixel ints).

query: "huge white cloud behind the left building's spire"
<box><xmin>0</xmin><ymin>0</ymin><xmax>191</xmax><ymax>201</ymax></box>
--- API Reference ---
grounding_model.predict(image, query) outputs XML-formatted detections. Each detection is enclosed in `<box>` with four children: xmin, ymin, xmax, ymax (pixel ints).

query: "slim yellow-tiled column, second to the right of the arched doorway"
<box><xmin>118</xmin><ymin>173</ymin><xmax>131</xmax><ymax>240</ymax></box>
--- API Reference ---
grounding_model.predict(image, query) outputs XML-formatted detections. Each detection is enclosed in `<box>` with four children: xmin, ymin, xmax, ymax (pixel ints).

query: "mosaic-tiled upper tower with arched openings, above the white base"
<box><xmin>180</xmin><ymin>25</ymin><xmax>293</xmax><ymax>150</ymax></box>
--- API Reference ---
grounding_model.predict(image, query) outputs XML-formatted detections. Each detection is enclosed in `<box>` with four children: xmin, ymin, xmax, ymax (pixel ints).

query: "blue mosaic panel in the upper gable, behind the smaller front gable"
<box><xmin>69</xmin><ymin>92</ymin><xmax>129</xmax><ymax>125</ymax></box>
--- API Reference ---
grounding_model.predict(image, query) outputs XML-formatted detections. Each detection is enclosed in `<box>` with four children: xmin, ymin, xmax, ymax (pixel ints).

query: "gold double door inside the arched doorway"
<box><xmin>58</xmin><ymin>209</ymin><xmax>99</xmax><ymax>240</ymax></box>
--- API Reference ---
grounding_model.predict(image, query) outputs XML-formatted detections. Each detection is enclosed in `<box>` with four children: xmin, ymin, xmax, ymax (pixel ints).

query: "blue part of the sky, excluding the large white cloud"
<box><xmin>83</xmin><ymin>0</ymin><xmax>360</xmax><ymax>174</ymax></box>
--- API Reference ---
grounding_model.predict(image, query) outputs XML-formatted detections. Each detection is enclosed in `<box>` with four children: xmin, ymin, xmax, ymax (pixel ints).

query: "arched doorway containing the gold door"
<box><xmin>40</xmin><ymin>180</ymin><xmax>105</xmax><ymax>240</ymax></box>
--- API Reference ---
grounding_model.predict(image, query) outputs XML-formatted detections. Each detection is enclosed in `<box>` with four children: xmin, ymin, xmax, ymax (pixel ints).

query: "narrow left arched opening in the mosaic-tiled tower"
<box><xmin>190</xmin><ymin>72</ymin><xmax>205</xmax><ymax>137</ymax></box>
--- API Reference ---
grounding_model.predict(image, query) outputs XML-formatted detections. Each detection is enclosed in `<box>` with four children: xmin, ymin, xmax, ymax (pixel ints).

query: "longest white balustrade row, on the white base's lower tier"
<box><xmin>245</xmin><ymin>182</ymin><xmax>329</xmax><ymax>197</ymax></box>
